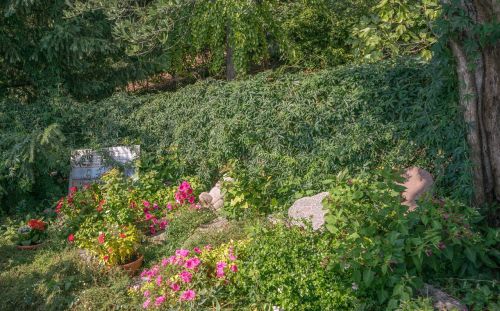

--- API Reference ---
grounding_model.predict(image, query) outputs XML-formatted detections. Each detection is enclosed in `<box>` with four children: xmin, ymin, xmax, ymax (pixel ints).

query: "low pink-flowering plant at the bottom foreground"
<box><xmin>134</xmin><ymin>243</ymin><xmax>242</xmax><ymax>308</ymax></box>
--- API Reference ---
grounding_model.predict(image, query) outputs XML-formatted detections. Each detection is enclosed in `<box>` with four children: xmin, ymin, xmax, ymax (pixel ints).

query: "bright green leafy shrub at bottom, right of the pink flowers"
<box><xmin>232</xmin><ymin>225</ymin><xmax>357</xmax><ymax>310</ymax></box>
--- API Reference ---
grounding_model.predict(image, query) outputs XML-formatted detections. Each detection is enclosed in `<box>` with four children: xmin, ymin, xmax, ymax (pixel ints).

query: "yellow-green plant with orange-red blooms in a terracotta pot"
<box><xmin>72</xmin><ymin>221</ymin><xmax>144</xmax><ymax>274</ymax></box>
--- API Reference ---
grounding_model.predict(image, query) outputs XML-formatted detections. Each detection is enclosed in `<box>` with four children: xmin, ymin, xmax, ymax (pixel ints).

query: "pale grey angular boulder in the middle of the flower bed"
<box><xmin>288</xmin><ymin>192</ymin><xmax>329</xmax><ymax>230</ymax></box>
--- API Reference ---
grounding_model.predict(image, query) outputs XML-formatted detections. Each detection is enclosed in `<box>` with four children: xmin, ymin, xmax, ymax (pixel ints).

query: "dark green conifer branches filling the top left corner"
<box><xmin>0</xmin><ymin>0</ymin><xmax>146</xmax><ymax>98</ymax></box>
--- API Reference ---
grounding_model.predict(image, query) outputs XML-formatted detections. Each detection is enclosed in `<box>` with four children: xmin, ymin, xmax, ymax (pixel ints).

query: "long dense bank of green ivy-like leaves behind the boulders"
<box><xmin>111</xmin><ymin>60</ymin><xmax>468</xmax><ymax>195</ymax></box>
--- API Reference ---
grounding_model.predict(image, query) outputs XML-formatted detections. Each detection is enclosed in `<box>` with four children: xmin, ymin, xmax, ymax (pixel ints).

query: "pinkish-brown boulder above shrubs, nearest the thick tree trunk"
<box><xmin>401</xmin><ymin>167</ymin><xmax>434</xmax><ymax>211</ymax></box>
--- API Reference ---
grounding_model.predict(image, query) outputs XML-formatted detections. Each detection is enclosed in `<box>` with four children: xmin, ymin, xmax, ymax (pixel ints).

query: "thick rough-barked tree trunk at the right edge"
<box><xmin>449</xmin><ymin>0</ymin><xmax>500</xmax><ymax>205</ymax></box>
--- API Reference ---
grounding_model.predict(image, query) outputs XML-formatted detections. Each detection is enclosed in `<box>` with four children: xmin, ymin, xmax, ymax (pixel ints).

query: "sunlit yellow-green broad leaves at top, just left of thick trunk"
<box><xmin>351</xmin><ymin>0</ymin><xmax>440</xmax><ymax>61</ymax></box>
